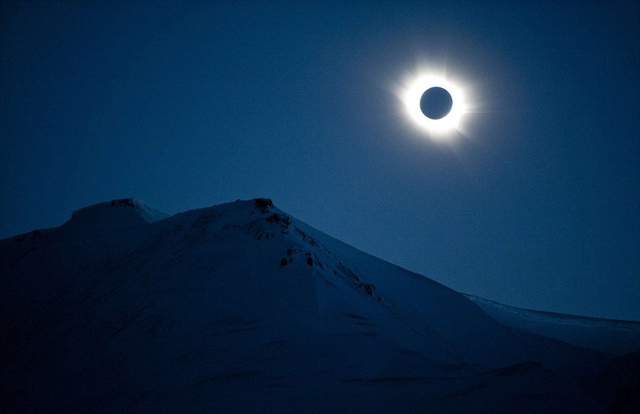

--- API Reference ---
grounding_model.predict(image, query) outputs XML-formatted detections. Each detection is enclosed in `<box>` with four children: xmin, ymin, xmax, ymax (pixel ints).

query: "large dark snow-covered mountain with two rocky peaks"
<box><xmin>0</xmin><ymin>199</ymin><xmax>640</xmax><ymax>413</ymax></box>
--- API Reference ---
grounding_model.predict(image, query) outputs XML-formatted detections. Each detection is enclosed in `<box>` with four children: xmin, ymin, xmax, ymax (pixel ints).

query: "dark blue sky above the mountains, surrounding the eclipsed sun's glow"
<box><xmin>0</xmin><ymin>1</ymin><xmax>640</xmax><ymax>320</ymax></box>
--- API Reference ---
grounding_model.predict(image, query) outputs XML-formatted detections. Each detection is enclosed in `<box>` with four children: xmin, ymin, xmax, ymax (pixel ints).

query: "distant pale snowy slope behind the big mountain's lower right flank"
<box><xmin>465</xmin><ymin>295</ymin><xmax>640</xmax><ymax>355</ymax></box>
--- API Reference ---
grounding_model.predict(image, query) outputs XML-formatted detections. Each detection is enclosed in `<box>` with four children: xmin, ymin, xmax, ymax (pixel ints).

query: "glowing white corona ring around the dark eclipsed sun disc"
<box><xmin>400</xmin><ymin>74</ymin><xmax>467</xmax><ymax>138</ymax></box>
